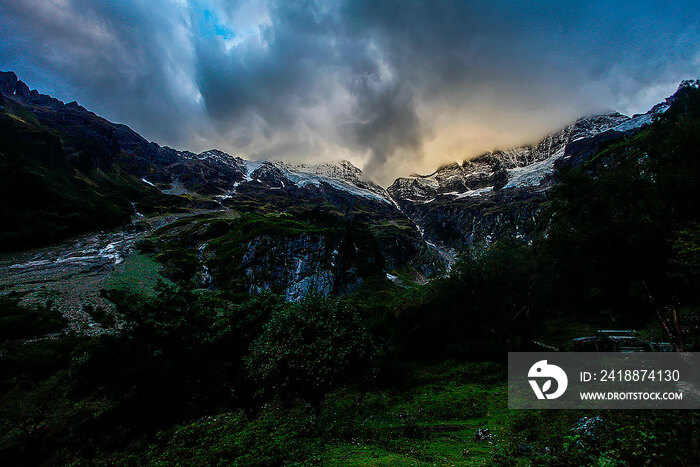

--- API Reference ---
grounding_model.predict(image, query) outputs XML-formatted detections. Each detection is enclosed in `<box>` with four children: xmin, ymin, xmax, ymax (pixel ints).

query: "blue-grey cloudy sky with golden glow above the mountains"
<box><xmin>0</xmin><ymin>0</ymin><xmax>700</xmax><ymax>184</ymax></box>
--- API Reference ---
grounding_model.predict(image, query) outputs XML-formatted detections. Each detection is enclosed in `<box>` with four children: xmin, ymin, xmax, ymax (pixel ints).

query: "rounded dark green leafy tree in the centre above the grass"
<box><xmin>246</xmin><ymin>296</ymin><xmax>376</xmax><ymax>409</ymax></box>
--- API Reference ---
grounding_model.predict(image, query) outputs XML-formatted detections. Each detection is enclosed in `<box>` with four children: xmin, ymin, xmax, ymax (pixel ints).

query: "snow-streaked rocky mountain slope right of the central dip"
<box><xmin>388</xmin><ymin>82</ymin><xmax>696</xmax><ymax>250</ymax></box>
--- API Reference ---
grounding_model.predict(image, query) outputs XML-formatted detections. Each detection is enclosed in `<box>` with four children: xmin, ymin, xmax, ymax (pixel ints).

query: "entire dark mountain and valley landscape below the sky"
<box><xmin>0</xmin><ymin>74</ymin><xmax>700</xmax><ymax>466</ymax></box>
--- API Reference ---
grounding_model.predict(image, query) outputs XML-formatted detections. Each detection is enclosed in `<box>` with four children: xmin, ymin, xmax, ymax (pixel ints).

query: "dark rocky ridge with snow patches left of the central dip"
<box><xmin>0</xmin><ymin>72</ymin><xmax>391</xmax><ymax>213</ymax></box>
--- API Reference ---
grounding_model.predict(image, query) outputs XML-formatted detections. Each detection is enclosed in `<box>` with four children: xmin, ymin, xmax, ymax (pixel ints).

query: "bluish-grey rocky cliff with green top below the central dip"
<box><xmin>147</xmin><ymin>209</ymin><xmax>444</xmax><ymax>300</ymax></box>
